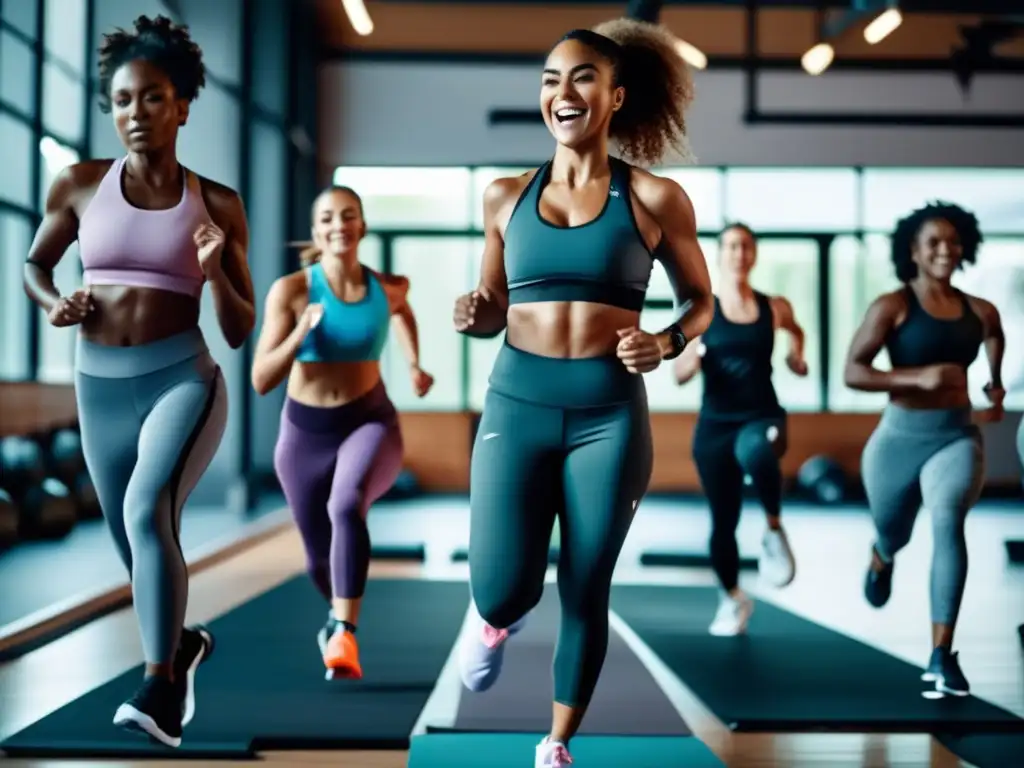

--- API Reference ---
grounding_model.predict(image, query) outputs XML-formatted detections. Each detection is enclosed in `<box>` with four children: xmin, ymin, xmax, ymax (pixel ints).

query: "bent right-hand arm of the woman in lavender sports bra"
<box><xmin>196</xmin><ymin>185</ymin><xmax>256</xmax><ymax>349</ymax></box>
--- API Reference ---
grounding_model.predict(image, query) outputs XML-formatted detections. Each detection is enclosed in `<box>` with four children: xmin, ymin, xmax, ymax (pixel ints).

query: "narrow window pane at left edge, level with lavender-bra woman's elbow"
<box><xmin>0</xmin><ymin>212</ymin><xmax>32</xmax><ymax>379</ymax></box>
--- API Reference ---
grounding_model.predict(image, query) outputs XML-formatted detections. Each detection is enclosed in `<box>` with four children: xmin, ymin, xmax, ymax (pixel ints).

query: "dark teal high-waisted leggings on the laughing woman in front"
<box><xmin>469</xmin><ymin>345</ymin><xmax>652</xmax><ymax>707</ymax></box>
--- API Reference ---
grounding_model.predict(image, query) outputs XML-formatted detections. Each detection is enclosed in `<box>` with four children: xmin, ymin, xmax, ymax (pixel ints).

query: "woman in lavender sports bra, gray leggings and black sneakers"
<box><xmin>25</xmin><ymin>16</ymin><xmax>255</xmax><ymax>746</ymax></box>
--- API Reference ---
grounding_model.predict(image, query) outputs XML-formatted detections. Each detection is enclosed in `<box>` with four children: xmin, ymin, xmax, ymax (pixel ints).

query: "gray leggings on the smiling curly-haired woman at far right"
<box><xmin>861</xmin><ymin>403</ymin><xmax>985</xmax><ymax>626</ymax></box>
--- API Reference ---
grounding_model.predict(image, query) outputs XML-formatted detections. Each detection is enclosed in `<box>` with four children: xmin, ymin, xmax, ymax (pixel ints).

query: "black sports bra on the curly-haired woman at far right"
<box><xmin>886</xmin><ymin>286</ymin><xmax>985</xmax><ymax>369</ymax></box>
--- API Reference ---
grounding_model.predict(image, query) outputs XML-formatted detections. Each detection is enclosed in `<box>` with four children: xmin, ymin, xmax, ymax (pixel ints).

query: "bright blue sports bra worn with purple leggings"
<box><xmin>296</xmin><ymin>262</ymin><xmax>391</xmax><ymax>362</ymax></box>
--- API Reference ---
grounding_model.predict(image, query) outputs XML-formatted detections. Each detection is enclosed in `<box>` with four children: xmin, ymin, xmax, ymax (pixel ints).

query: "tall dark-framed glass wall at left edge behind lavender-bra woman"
<box><xmin>0</xmin><ymin>0</ymin><xmax>89</xmax><ymax>382</ymax></box>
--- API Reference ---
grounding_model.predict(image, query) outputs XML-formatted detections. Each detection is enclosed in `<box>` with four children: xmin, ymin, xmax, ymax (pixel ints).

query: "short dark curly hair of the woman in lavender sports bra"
<box><xmin>99</xmin><ymin>15</ymin><xmax>206</xmax><ymax>113</ymax></box>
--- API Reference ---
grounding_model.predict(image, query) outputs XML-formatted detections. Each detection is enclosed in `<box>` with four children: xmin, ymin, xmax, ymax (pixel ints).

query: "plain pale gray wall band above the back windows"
<box><xmin>319</xmin><ymin>60</ymin><xmax>1024</xmax><ymax>167</ymax></box>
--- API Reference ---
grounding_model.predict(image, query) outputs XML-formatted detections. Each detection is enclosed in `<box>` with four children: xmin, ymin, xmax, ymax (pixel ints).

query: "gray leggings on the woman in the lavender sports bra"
<box><xmin>75</xmin><ymin>330</ymin><xmax>227</xmax><ymax>664</ymax></box>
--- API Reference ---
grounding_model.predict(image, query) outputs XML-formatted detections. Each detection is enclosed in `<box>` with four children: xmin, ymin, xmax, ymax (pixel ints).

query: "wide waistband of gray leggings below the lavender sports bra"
<box><xmin>75</xmin><ymin>328</ymin><xmax>210</xmax><ymax>379</ymax></box>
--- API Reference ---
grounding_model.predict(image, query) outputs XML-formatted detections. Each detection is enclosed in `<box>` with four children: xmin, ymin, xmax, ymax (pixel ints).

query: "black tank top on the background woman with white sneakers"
<box><xmin>700</xmin><ymin>291</ymin><xmax>784</xmax><ymax>421</ymax></box>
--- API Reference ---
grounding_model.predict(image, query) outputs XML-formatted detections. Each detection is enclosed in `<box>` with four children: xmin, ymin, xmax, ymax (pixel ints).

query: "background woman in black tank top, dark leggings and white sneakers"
<box><xmin>675</xmin><ymin>223</ymin><xmax>807</xmax><ymax>636</ymax></box>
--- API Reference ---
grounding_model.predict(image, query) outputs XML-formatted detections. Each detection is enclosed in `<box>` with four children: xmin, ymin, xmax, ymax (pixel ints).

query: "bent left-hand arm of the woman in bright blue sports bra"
<box><xmin>252</xmin><ymin>278</ymin><xmax>309</xmax><ymax>394</ymax></box>
